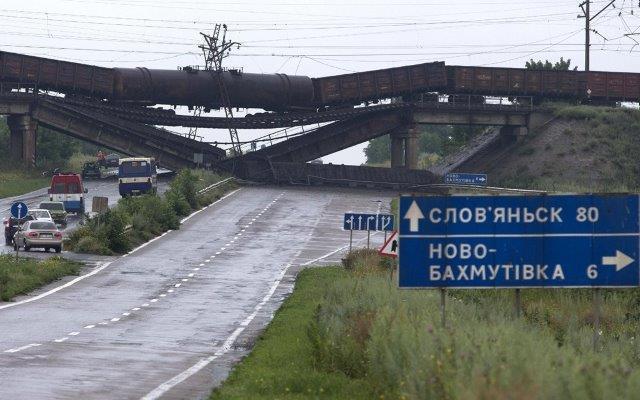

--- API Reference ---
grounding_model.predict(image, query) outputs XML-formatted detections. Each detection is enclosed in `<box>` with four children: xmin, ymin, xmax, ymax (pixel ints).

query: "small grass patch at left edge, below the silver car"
<box><xmin>0</xmin><ymin>255</ymin><xmax>82</xmax><ymax>301</ymax></box>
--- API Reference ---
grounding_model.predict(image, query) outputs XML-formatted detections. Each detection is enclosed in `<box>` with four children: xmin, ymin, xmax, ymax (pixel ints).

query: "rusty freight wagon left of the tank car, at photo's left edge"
<box><xmin>0</xmin><ymin>52</ymin><xmax>114</xmax><ymax>98</ymax></box>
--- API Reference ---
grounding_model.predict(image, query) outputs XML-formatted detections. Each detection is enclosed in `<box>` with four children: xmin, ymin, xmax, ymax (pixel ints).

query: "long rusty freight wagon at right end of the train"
<box><xmin>447</xmin><ymin>66</ymin><xmax>640</xmax><ymax>102</ymax></box>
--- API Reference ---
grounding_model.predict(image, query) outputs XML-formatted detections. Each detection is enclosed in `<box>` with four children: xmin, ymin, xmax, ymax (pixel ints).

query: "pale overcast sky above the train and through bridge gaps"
<box><xmin>0</xmin><ymin>0</ymin><xmax>640</xmax><ymax>164</ymax></box>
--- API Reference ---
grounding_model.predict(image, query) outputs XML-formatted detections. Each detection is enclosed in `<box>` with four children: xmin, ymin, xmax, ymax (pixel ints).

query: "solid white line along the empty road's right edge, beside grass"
<box><xmin>142</xmin><ymin>264</ymin><xmax>291</xmax><ymax>400</ymax></box>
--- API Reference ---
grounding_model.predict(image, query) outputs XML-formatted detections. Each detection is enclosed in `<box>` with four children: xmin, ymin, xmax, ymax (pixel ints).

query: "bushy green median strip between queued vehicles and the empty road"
<box><xmin>65</xmin><ymin>170</ymin><xmax>235</xmax><ymax>255</ymax></box>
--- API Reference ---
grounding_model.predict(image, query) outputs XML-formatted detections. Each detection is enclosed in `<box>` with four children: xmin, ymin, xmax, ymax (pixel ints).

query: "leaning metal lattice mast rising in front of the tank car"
<box><xmin>199</xmin><ymin>24</ymin><xmax>242</xmax><ymax>155</ymax></box>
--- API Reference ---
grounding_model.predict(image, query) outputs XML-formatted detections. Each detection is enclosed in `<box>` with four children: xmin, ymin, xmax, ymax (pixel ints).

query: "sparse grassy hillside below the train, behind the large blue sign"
<box><xmin>440</xmin><ymin>104</ymin><xmax>640</xmax><ymax>191</ymax></box>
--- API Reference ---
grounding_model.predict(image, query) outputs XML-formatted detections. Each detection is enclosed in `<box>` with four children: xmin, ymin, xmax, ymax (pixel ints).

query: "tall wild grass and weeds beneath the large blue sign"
<box><xmin>309</xmin><ymin>252</ymin><xmax>640</xmax><ymax>399</ymax></box>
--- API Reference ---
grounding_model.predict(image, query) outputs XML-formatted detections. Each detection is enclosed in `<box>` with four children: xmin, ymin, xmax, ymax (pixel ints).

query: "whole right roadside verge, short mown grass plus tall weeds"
<box><xmin>212</xmin><ymin>248</ymin><xmax>640</xmax><ymax>399</ymax></box>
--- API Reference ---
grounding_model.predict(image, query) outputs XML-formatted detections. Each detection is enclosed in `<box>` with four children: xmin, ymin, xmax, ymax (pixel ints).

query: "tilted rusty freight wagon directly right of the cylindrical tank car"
<box><xmin>313</xmin><ymin>62</ymin><xmax>447</xmax><ymax>106</ymax></box>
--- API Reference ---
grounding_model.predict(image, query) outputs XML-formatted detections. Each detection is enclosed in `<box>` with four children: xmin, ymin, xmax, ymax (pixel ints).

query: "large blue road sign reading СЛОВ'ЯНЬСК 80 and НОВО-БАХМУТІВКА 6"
<box><xmin>399</xmin><ymin>194</ymin><xmax>640</xmax><ymax>288</ymax></box>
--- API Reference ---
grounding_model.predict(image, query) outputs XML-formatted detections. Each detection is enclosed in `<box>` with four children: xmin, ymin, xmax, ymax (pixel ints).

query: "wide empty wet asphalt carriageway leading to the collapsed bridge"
<box><xmin>0</xmin><ymin>187</ymin><xmax>390</xmax><ymax>399</ymax></box>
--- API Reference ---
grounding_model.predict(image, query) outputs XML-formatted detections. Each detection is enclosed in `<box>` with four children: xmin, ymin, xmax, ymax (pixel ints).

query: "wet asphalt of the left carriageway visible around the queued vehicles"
<box><xmin>0</xmin><ymin>177</ymin><xmax>170</xmax><ymax>258</ymax></box>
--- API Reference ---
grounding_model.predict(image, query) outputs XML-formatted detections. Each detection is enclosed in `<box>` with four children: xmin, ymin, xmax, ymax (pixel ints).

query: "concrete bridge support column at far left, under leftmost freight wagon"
<box><xmin>7</xmin><ymin>114</ymin><xmax>37</xmax><ymax>167</ymax></box>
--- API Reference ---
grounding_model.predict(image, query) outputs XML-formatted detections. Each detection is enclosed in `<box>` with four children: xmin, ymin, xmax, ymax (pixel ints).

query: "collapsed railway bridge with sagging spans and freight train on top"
<box><xmin>0</xmin><ymin>52</ymin><xmax>640</xmax><ymax>187</ymax></box>
